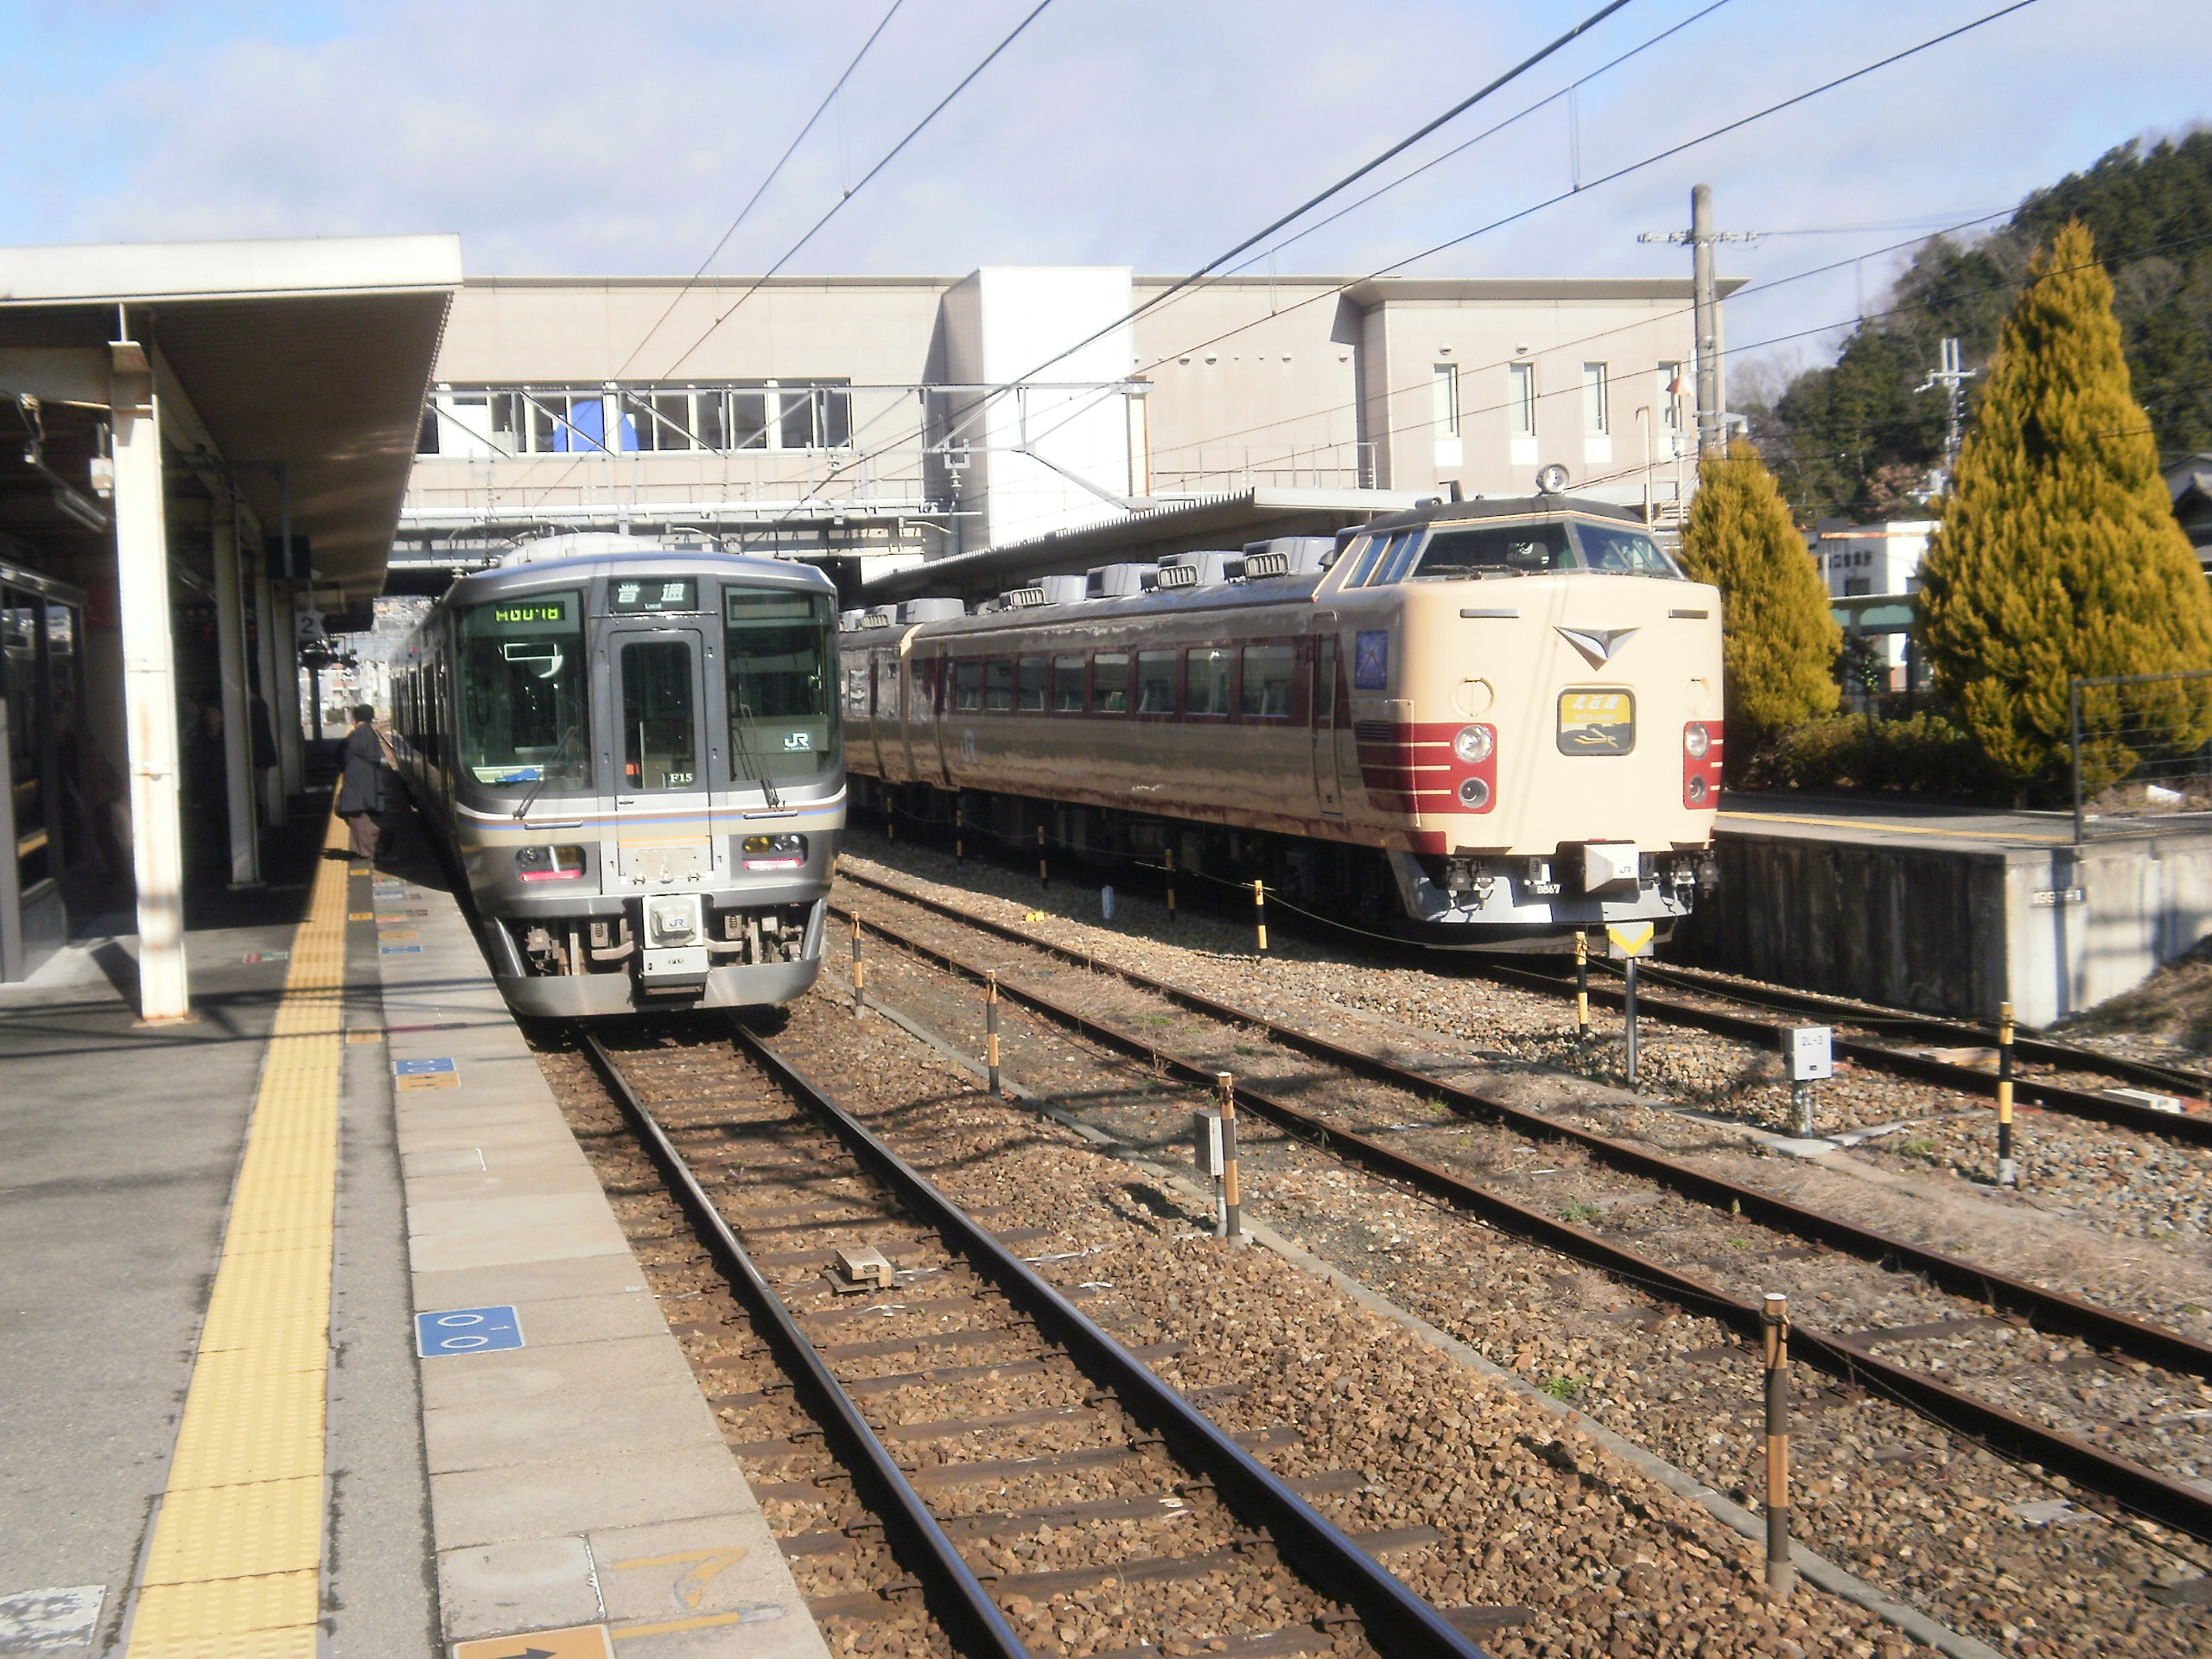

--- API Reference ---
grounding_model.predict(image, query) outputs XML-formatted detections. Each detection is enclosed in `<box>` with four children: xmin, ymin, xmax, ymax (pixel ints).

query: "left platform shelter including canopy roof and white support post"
<box><xmin>0</xmin><ymin>237</ymin><xmax>460</xmax><ymax>1000</ymax></box>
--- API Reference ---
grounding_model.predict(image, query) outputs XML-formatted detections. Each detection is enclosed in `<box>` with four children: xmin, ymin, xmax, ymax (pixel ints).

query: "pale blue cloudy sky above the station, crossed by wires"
<box><xmin>0</xmin><ymin>0</ymin><xmax>2212</xmax><ymax>380</ymax></box>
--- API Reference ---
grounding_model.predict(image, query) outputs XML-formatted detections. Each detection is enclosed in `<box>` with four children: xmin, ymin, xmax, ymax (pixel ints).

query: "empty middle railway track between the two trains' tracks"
<box><xmin>827</xmin><ymin>869</ymin><xmax>2212</xmax><ymax>1540</ymax></box>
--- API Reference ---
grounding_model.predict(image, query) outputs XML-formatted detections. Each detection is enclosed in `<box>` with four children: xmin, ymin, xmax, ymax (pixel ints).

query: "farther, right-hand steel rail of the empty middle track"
<box><xmin>832</xmin><ymin>872</ymin><xmax>2212</xmax><ymax>1380</ymax></box>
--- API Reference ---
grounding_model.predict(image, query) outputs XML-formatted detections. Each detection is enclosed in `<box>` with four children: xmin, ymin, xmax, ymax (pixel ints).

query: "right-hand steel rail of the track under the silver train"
<box><xmin>734</xmin><ymin>1024</ymin><xmax>1486</xmax><ymax>1659</ymax></box>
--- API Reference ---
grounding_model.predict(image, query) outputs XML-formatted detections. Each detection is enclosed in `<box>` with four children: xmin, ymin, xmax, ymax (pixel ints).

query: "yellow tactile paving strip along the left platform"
<box><xmin>126</xmin><ymin>817</ymin><xmax>349</xmax><ymax>1659</ymax></box>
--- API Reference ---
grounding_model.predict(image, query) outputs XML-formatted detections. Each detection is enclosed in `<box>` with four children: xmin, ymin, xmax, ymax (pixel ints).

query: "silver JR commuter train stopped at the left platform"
<box><xmin>391</xmin><ymin>536</ymin><xmax>845</xmax><ymax>1018</ymax></box>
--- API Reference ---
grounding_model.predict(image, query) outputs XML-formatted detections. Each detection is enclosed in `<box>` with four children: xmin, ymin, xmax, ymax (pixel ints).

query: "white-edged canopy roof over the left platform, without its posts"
<box><xmin>0</xmin><ymin>234</ymin><xmax>462</xmax><ymax>597</ymax></box>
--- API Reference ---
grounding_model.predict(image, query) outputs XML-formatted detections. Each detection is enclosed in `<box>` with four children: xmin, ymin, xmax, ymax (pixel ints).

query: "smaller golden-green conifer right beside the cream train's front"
<box><xmin>1681</xmin><ymin>442</ymin><xmax>1842</xmax><ymax>772</ymax></box>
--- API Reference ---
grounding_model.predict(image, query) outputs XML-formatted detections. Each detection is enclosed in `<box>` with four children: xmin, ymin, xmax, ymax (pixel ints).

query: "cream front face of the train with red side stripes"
<box><xmin>1334</xmin><ymin>498</ymin><xmax>1721</xmax><ymax>944</ymax></box>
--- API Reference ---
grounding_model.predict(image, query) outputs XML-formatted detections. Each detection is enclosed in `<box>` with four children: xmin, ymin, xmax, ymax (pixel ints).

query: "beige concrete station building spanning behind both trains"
<box><xmin>407</xmin><ymin>268</ymin><xmax>1694</xmax><ymax>588</ymax></box>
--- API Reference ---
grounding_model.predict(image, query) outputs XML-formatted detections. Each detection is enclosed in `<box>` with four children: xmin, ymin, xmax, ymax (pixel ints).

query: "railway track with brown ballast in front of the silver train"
<box><xmin>580</xmin><ymin>1027</ymin><xmax>1520</xmax><ymax>1659</ymax></box>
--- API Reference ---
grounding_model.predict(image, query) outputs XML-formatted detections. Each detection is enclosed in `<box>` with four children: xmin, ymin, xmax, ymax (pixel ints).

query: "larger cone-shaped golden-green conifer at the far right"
<box><xmin>1918</xmin><ymin>221</ymin><xmax>2212</xmax><ymax>790</ymax></box>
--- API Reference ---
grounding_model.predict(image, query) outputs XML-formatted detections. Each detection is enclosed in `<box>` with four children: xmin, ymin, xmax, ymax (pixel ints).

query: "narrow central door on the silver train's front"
<box><xmin>606</xmin><ymin>626</ymin><xmax>719</xmax><ymax>887</ymax></box>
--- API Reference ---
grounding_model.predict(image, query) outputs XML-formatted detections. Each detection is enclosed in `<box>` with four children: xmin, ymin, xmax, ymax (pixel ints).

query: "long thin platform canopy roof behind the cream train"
<box><xmin>862</xmin><ymin>486</ymin><xmax>1433</xmax><ymax>604</ymax></box>
